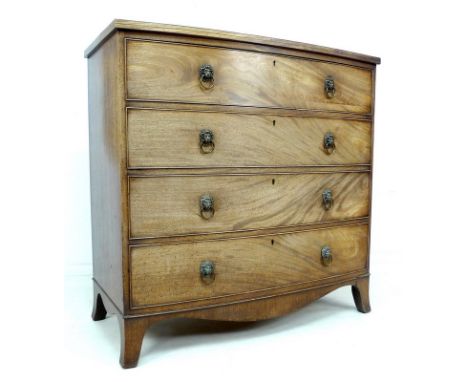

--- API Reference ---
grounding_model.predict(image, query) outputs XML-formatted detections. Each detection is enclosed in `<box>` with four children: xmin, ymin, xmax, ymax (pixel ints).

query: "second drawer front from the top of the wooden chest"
<box><xmin>127</xmin><ymin>109</ymin><xmax>371</xmax><ymax>168</ymax></box>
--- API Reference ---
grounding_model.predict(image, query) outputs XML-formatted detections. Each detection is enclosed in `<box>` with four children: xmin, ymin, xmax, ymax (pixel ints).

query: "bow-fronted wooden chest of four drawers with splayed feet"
<box><xmin>85</xmin><ymin>20</ymin><xmax>380</xmax><ymax>367</ymax></box>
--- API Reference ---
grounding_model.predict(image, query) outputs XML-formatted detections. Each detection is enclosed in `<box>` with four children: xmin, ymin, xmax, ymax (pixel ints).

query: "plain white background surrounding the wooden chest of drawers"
<box><xmin>0</xmin><ymin>0</ymin><xmax>468</xmax><ymax>381</ymax></box>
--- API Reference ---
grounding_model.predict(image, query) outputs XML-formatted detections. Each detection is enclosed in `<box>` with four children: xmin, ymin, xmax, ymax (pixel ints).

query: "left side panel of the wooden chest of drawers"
<box><xmin>88</xmin><ymin>35</ymin><xmax>128</xmax><ymax>311</ymax></box>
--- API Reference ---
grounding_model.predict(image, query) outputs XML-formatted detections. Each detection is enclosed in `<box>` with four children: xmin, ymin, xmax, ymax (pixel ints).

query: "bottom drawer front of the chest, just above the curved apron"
<box><xmin>130</xmin><ymin>225</ymin><xmax>368</xmax><ymax>307</ymax></box>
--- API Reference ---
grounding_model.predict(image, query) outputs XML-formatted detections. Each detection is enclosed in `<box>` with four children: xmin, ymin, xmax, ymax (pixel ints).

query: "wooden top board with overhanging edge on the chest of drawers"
<box><xmin>85</xmin><ymin>20</ymin><xmax>380</xmax><ymax>64</ymax></box>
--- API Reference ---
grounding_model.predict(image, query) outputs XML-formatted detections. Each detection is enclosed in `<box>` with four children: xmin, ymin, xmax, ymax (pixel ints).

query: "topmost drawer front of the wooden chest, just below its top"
<box><xmin>126</xmin><ymin>40</ymin><xmax>372</xmax><ymax>114</ymax></box>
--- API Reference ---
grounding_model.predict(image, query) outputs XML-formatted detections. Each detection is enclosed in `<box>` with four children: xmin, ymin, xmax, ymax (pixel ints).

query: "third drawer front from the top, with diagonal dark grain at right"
<box><xmin>129</xmin><ymin>173</ymin><xmax>369</xmax><ymax>238</ymax></box>
